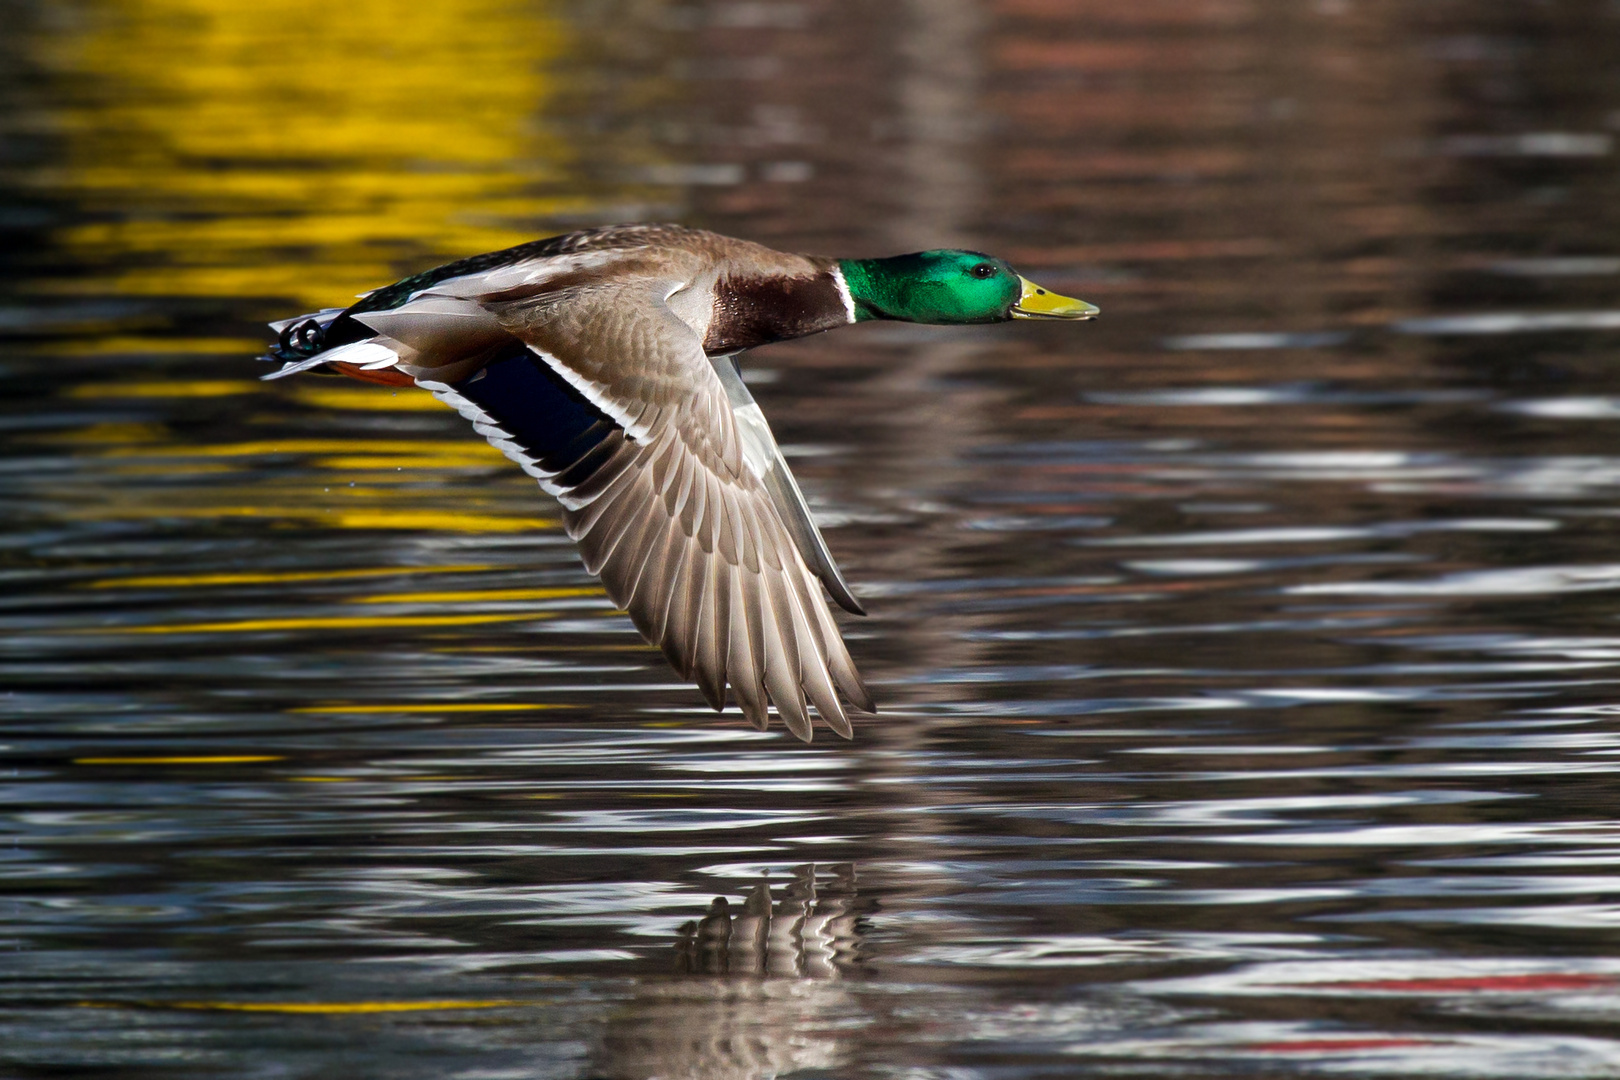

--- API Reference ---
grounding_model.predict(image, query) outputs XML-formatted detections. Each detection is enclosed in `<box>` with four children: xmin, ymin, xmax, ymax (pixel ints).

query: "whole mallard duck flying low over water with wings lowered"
<box><xmin>266</xmin><ymin>225</ymin><xmax>1097</xmax><ymax>742</ymax></box>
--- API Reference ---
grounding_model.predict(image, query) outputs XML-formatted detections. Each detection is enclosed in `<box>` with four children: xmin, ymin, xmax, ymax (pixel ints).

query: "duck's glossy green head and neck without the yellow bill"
<box><xmin>838</xmin><ymin>251</ymin><xmax>1019</xmax><ymax>324</ymax></box>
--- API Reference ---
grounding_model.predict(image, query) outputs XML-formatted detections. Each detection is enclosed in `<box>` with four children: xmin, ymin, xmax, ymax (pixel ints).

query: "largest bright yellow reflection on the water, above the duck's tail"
<box><xmin>39</xmin><ymin>0</ymin><xmax>582</xmax><ymax>306</ymax></box>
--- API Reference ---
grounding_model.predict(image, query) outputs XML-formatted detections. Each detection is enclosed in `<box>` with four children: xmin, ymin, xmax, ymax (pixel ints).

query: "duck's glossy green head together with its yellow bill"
<box><xmin>838</xmin><ymin>251</ymin><xmax>1097</xmax><ymax>324</ymax></box>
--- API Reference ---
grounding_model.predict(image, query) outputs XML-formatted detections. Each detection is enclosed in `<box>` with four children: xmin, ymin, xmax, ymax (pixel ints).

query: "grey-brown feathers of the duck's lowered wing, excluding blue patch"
<box><xmin>492</xmin><ymin>282</ymin><xmax>873</xmax><ymax>740</ymax></box>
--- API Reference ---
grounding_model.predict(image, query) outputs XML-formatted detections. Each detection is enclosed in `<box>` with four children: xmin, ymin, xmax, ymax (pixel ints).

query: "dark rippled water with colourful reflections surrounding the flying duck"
<box><xmin>9</xmin><ymin>0</ymin><xmax>1620</xmax><ymax>1080</ymax></box>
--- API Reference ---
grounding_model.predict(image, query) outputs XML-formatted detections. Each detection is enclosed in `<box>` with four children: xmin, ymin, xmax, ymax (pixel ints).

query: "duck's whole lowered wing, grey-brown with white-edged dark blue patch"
<box><xmin>350</xmin><ymin>280</ymin><xmax>873</xmax><ymax>740</ymax></box>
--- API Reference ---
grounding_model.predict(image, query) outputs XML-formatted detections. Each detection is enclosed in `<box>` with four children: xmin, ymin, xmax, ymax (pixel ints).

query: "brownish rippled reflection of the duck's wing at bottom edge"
<box><xmin>591</xmin><ymin>865</ymin><xmax>875</xmax><ymax>1080</ymax></box>
